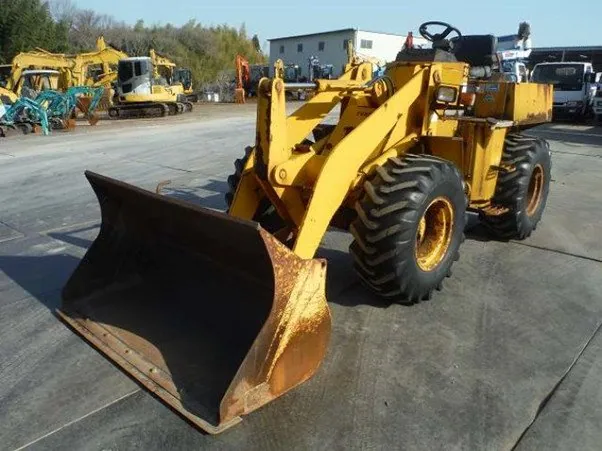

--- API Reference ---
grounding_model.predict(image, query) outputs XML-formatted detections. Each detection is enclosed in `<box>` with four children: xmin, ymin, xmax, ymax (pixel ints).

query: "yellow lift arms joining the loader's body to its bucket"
<box><xmin>230</xmin><ymin>63</ymin><xmax>430</xmax><ymax>258</ymax></box>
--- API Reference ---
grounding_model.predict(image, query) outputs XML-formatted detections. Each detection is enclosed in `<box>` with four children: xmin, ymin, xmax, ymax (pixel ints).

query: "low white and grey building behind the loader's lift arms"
<box><xmin>269</xmin><ymin>28</ymin><xmax>430</xmax><ymax>77</ymax></box>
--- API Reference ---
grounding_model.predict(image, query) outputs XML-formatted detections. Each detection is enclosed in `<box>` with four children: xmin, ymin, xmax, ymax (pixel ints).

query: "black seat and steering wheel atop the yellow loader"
<box><xmin>396</xmin><ymin>21</ymin><xmax>497</xmax><ymax>78</ymax></box>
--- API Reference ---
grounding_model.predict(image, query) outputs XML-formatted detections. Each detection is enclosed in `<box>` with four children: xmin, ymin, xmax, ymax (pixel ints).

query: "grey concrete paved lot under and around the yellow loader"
<box><xmin>0</xmin><ymin>110</ymin><xmax>602</xmax><ymax>450</ymax></box>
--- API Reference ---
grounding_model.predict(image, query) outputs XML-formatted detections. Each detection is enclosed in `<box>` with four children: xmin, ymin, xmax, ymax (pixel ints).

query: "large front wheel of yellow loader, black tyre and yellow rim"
<box><xmin>349</xmin><ymin>154</ymin><xmax>466</xmax><ymax>304</ymax></box>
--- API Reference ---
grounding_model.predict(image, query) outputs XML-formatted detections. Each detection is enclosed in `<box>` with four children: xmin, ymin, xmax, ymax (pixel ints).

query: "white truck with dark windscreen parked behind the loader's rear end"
<box><xmin>531</xmin><ymin>62</ymin><xmax>597</xmax><ymax>120</ymax></box>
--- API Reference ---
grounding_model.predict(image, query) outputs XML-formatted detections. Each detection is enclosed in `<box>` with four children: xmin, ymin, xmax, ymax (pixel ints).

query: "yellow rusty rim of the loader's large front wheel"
<box><xmin>416</xmin><ymin>197</ymin><xmax>454</xmax><ymax>272</ymax></box>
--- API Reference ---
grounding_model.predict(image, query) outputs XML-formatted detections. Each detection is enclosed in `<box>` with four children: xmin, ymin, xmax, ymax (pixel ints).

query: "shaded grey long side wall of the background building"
<box><xmin>270</xmin><ymin>30</ymin><xmax>355</xmax><ymax>77</ymax></box>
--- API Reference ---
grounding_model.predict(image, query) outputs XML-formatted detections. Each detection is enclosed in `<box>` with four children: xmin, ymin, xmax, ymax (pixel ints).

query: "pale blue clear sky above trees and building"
<box><xmin>75</xmin><ymin>0</ymin><xmax>602</xmax><ymax>47</ymax></box>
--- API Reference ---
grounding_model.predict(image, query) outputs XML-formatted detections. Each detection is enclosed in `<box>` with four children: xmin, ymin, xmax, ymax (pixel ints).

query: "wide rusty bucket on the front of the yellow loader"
<box><xmin>58</xmin><ymin>172</ymin><xmax>331</xmax><ymax>433</ymax></box>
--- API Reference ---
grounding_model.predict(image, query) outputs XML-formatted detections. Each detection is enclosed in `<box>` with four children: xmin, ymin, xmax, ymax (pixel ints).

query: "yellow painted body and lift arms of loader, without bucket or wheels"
<box><xmin>231</xmin><ymin>56</ymin><xmax>548</xmax><ymax>258</ymax></box>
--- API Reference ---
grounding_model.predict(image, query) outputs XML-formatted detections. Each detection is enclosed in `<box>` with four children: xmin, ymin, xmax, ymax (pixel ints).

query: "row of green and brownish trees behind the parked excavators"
<box><xmin>0</xmin><ymin>0</ymin><xmax>267</xmax><ymax>86</ymax></box>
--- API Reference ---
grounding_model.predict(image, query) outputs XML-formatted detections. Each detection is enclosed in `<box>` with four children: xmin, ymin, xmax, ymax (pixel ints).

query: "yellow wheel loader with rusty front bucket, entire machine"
<box><xmin>60</xmin><ymin>23</ymin><xmax>552</xmax><ymax>433</ymax></box>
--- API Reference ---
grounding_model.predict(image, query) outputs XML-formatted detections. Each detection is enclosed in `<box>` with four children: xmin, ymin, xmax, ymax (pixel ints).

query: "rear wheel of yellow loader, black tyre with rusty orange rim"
<box><xmin>481</xmin><ymin>133</ymin><xmax>552</xmax><ymax>240</ymax></box>
